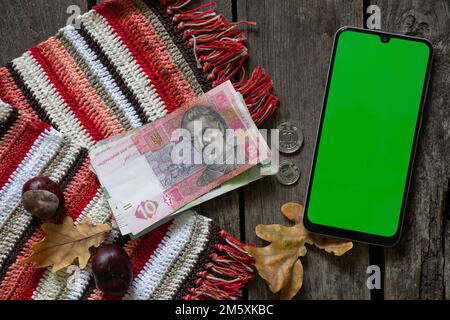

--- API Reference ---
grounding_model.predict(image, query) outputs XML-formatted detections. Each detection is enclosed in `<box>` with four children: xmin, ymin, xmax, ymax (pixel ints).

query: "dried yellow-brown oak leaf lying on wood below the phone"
<box><xmin>246</xmin><ymin>203</ymin><xmax>353</xmax><ymax>300</ymax></box>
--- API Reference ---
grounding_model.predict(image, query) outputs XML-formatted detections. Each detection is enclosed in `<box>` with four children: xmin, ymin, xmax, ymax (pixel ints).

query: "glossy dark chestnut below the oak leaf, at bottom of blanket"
<box><xmin>92</xmin><ymin>244</ymin><xmax>133</xmax><ymax>295</ymax></box>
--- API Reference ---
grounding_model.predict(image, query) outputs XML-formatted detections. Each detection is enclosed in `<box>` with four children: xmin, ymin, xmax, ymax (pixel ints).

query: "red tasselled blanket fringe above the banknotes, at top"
<box><xmin>160</xmin><ymin>0</ymin><xmax>279</xmax><ymax>125</ymax></box>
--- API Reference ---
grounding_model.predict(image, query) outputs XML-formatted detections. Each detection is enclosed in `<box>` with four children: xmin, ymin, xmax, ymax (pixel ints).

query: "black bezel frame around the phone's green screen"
<box><xmin>303</xmin><ymin>26</ymin><xmax>433</xmax><ymax>247</ymax></box>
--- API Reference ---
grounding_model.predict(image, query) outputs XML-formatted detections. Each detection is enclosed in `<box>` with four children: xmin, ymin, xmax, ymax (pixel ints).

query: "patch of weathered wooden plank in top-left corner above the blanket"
<box><xmin>0</xmin><ymin>0</ymin><xmax>87</xmax><ymax>66</ymax></box>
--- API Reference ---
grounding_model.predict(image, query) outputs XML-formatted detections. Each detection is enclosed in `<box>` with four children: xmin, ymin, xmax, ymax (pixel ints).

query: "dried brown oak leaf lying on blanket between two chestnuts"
<box><xmin>21</xmin><ymin>217</ymin><xmax>111</xmax><ymax>272</ymax></box>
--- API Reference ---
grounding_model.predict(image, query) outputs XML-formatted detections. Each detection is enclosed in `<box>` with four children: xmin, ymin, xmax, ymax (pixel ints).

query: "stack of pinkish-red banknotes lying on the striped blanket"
<box><xmin>89</xmin><ymin>82</ymin><xmax>278</xmax><ymax>237</ymax></box>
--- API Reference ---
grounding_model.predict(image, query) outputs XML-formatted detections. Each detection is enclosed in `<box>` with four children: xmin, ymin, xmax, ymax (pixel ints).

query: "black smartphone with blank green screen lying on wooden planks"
<box><xmin>304</xmin><ymin>27</ymin><xmax>433</xmax><ymax>246</ymax></box>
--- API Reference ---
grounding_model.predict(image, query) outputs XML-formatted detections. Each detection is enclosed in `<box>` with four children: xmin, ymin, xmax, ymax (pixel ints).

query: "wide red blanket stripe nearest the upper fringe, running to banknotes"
<box><xmin>95</xmin><ymin>1</ymin><xmax>180</xmax><ymax>112</ymax></box>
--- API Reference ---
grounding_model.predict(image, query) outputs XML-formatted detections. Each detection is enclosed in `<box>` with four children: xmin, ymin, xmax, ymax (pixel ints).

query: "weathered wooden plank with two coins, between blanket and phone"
<box><xmin>237</xmin><ymin>0</ymin><xmax>370</xmax><ymax>299</ymax></box>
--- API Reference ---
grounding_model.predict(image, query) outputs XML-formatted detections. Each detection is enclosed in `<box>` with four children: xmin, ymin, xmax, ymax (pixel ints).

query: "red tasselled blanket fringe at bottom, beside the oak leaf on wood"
<box><xmin>183</xmin><ymin>231</ymin><xmax>254</xmax><ymax>300</ymax></box>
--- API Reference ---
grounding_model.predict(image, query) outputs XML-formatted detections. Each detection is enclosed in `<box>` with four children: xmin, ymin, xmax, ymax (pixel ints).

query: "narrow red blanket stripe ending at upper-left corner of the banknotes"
<box><xmin>30</xmin><ymin>46</ymin><xmax>106</xmax><ymax>141</ymax></box>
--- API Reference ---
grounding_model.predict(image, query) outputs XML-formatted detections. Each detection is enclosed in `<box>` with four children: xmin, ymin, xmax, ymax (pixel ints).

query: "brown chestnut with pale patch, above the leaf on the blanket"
<box><xmin>22</xmin><ymin>177</ymin><xmax>64</xmax><ymax>220</ymax></box>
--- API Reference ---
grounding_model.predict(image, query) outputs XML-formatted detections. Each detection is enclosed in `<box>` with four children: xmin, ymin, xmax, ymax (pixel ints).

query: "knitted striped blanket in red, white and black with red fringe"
<box><xmin>0</xmin><ymin>0</ymin><xmax>278</xmax><ymax>299</ymax></box>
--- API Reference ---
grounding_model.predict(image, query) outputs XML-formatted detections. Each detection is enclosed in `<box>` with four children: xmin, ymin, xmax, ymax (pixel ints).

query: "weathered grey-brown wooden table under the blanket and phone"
<box><xmin>0</xmin><ymin>0</ymin><xmax>450</xmax><ymax>299</ymax></box>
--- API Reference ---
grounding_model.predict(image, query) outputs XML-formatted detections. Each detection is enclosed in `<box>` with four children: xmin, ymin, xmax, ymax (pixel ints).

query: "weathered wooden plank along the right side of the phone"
<box><xmin>372</xmin><ymin>0</ymin><xmax>450</xmax><ymax>299</ymax></box>
